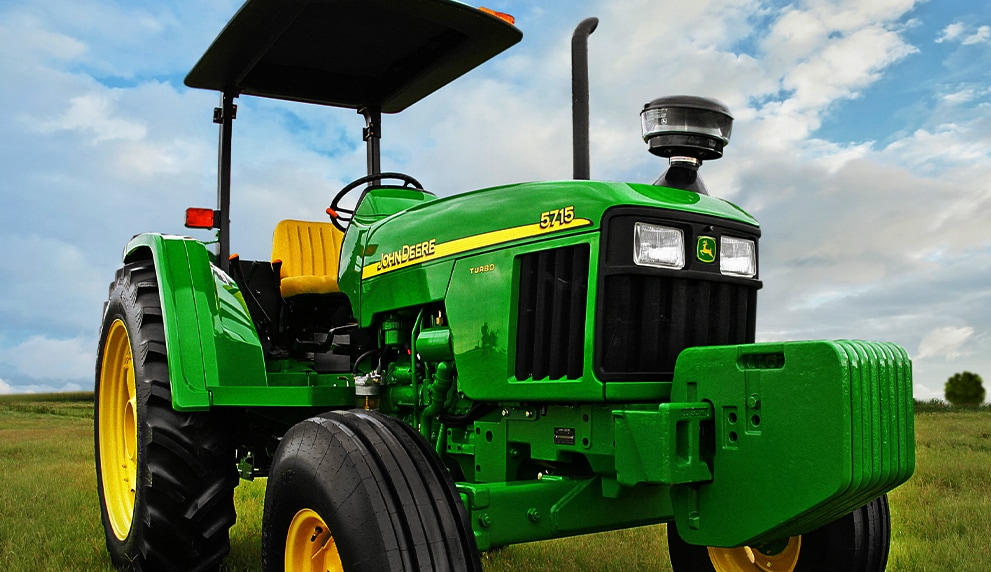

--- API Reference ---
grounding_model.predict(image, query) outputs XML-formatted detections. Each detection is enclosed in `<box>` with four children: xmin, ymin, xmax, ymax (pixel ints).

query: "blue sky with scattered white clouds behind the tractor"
<box><xmin>0</xmin><ymin>0</ymin><xmax>991</xmax><ymax>400</ymax></box>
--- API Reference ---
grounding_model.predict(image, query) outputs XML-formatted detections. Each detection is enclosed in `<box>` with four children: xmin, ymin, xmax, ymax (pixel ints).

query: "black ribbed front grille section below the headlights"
<box><xmin>597</xmin><ymin>274</ymin><xmax>757</xmax><ymax>380</ymax></box>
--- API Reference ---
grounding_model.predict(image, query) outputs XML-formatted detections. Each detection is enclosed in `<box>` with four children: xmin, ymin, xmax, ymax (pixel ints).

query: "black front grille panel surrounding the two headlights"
<box><xmin>595</xmin><ymin>207</ymin><xmax>761</xmax><ymax>381</ymax></box>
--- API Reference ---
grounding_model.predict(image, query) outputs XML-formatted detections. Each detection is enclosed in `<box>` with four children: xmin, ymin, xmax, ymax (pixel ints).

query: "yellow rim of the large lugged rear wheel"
<box><xmin>97</xmin><ymin>320</ymin><xmax>138</xmax><ymax>540</ymax></box>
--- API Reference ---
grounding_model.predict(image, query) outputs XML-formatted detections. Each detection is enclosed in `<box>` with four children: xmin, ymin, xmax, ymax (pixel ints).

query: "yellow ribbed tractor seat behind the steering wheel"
<box><xmin>272</xmin><ymin>220</ymin><xmax>344</xmax><ymax>298</ymax></box>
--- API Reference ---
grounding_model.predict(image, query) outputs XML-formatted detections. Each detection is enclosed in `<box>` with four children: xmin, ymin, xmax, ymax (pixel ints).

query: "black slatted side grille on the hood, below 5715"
<box><xmin>516</xmin><ymin>244</ymin><xmax>589</xmax><ymax>379</ymax></box>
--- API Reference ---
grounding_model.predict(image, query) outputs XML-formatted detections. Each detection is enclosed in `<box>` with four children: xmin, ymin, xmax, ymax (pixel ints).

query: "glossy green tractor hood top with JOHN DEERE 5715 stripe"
<box><xmin>340</xmin><ymin>181</ymin><xmax>757</xmax><ymax>323</ymax></box>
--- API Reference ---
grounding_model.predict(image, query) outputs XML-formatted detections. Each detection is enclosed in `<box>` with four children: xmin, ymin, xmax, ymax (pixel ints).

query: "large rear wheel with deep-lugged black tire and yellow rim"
<box><xmin>94</xmin><ymin>261</ymin><xmax>238</xmax><ymax>572</ymax></box>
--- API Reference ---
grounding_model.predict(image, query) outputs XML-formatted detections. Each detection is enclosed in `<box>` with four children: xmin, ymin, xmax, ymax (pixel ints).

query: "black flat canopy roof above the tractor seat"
<box><xmin>186</xmin><ymin>0</ymin><xmax>523</xmax><ymax>113</ymax></box>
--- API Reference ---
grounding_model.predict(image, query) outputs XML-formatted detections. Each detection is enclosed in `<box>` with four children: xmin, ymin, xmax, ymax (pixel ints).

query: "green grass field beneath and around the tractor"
<box><xmin>0</xmin><ymin>393</ymin><xmax>991</xmax><ymax>572</ymax></box>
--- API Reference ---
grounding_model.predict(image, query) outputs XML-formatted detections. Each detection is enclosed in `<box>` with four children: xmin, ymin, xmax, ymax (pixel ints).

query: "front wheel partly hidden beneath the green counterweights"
<box><xmin>668</xmin><ymin>495</ymin><xmax>891</xmax><ymax>572</ymax></box>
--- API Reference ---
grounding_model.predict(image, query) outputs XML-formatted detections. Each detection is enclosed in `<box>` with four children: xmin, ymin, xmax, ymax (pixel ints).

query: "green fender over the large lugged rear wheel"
<box><xmin>124</xmin><ymin>233</ymin><xmax>267</xmax><ymax>411</ymax></box>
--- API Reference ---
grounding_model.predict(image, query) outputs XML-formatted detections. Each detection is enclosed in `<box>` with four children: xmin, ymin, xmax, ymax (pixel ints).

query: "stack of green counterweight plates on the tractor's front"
<box><xmin>671</xmin><ymin>341</ymin><xmax>915</xmax><ymax>547</ymax></box>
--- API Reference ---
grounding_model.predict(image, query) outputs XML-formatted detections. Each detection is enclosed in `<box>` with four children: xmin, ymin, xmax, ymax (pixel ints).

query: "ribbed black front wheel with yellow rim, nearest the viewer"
<box><xmin>262</xmin><ymin>410</ymin><xmax>481</xmax><ymax>572</ymax></box>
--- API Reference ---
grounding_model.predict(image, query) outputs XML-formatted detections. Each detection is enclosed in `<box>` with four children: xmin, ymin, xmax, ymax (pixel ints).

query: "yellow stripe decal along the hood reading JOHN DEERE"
<box><xmin>361</xmin><ymin>218</ymin><xmax>592</xmax><ymax>279</ymax></box>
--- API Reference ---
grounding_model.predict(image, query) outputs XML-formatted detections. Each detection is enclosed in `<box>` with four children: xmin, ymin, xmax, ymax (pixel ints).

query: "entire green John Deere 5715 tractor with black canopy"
<box><xmin>95</xmin><ymin>0</ymin><xmax>915</xmax><ymax>572</ymax></box>
